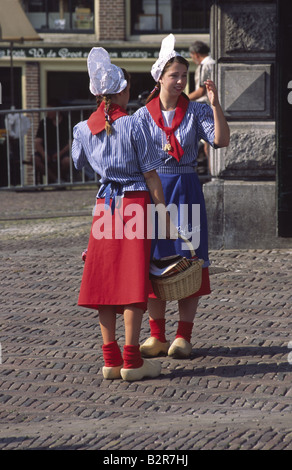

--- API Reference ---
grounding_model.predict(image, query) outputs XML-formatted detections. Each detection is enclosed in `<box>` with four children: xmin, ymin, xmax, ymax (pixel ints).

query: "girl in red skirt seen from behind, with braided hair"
<box><xmin>72</xmin><ymin>47</ymin><xmax>169</xmax><ymax>380</ymax></box>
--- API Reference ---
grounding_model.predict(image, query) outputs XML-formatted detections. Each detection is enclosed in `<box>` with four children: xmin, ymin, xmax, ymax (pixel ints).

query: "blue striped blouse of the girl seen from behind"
<box><xmin>72</xmin><ymin>116</ymin><xmax>161</xmax><ymax>197</ymax></box>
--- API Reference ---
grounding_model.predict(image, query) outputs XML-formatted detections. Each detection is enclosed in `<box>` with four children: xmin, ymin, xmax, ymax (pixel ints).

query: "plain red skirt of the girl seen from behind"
<box><xmin>78</xmin><ymin>191</ymin><xmax>151</xmax><ymax>313</ymax></box>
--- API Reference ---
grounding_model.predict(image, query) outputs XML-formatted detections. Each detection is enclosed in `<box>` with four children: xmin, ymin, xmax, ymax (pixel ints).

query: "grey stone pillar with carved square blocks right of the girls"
<box><xmin>204</xmin><ymin>0</ymin><xmax>292</xmax><ymax>249</ymax></box>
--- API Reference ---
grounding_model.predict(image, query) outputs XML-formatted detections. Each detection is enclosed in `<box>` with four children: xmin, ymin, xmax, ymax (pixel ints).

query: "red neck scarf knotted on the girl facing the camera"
<box><xmin>146</xmin><ymin>95</ymin><xmax>189</xmax><ymax>162</ymax></box>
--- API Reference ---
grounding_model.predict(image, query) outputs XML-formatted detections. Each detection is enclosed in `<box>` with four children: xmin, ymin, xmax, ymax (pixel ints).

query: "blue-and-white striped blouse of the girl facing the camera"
<box><xmin>133</xmin><ymin>101</ymin><xmax>215</xmax><ymax>173</ymax></box>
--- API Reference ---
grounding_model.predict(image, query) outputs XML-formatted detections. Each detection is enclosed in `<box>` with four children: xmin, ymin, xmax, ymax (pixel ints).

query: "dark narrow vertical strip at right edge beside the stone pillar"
<box><xmin>277</xmin><ymin>0</ymin><xmax>292</xmax><ymax>237</ymax></box>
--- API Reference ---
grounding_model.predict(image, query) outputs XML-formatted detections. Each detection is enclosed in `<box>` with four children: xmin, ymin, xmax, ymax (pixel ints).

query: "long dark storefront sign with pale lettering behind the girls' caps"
<box><xmin>0</xmin><ymin>46</ymin><xmax>190</xmax><ymax>59</ymax></box>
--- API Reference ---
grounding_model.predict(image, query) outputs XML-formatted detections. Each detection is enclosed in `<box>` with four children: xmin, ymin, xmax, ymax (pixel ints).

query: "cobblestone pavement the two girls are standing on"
<box><xmin>0</xmin><ymin>189</ymin><xmax>292</xmax><ymax>451</ymax></box>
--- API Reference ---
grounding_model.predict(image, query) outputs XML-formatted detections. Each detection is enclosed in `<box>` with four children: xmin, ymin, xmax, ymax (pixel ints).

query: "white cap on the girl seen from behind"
<box><xmin>87</xmin><ymin>47</ymin><xmax>127</xmax><ymax>96</ymax></box>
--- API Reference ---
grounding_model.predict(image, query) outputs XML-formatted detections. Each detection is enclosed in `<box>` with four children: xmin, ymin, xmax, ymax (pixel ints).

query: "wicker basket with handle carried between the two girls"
<box><xmin>150</xmin><ymin>235</ymin><xmax>204</xmax><ymax>300</ymax></box>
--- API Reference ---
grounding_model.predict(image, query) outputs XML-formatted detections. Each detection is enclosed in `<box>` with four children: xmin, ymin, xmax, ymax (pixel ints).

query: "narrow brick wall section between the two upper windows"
<box><xmin>99</xmin><ymin>0</ymin><xmax>126</xmax><ymax>41</ymax></box>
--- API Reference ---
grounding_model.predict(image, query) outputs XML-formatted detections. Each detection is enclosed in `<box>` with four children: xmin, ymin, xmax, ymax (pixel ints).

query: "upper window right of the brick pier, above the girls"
<box><xmin>130</xmin><ymin>0</ymin><xmax>212</xmax><ymax>34</ymax></box>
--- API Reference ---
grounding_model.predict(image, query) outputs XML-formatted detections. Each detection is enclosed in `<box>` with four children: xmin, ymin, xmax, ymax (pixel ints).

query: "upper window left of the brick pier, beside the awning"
<box><xmin>22</xmin><ymin>0</ymin><xmax>94</xmax><ymax>33</ymax></box>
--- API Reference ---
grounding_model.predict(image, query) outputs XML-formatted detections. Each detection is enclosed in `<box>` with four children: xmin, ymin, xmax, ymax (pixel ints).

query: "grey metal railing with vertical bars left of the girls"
<box><xmin>0</xmin><ymin>105</ymin><xmax>98</xmax><ymax>189</ymax></box>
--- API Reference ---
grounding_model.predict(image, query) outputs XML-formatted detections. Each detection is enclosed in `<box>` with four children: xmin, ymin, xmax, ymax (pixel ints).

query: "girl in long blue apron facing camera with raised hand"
<box><xmin>135</xmin><ymin>34</ymin><xmax>229</xmax><ymax>358</ymax></box>
